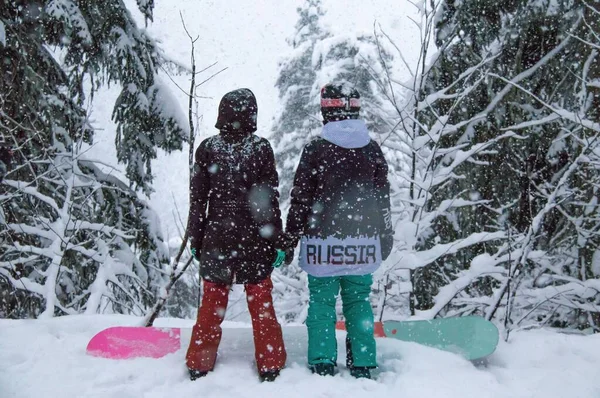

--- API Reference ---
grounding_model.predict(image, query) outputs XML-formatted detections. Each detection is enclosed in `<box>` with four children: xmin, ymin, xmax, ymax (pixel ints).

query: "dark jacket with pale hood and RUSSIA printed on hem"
<box><xmin>286</xmin><ymin>120</ymin><xmax>393</xmax><ymax>276</ymax></box>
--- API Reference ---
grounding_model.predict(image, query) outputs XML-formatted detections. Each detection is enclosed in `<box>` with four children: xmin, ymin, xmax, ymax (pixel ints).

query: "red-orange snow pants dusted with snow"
<box><xmin>186</xmin><ymin>277</ymin><xmax>286</xmax><ymax>373</ymax></box>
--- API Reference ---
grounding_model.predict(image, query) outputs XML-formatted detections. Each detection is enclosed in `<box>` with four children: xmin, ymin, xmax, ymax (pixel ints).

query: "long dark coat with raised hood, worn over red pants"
<box><xmin>188</xmin><ymin>89</ymin><xmax>281</xmax><ymax>284</ymax></box>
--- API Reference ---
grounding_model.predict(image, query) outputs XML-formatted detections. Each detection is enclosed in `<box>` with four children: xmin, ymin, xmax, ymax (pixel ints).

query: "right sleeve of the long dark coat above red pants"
<box><xmin>248</xmin><ymin>140</ymin><xmax>282</xmax><ymax>242</ymax></box>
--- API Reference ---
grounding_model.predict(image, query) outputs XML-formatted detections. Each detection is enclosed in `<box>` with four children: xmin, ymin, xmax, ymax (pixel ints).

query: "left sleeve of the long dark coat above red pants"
<box><xmin>187</xmin><ymin>140</ymin><xmax>210</xmax><ymax>251</ymax></box>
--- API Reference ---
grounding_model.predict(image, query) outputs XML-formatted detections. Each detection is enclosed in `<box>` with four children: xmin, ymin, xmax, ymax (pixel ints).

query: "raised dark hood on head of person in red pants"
<box><xmin>215</xmin><ymin>88</ymin><xmax>258</xmax><ymax>134</ymax></box>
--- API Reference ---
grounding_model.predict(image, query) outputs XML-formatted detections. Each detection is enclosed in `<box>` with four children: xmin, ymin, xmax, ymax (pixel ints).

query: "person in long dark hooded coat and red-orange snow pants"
<box><xmin>186</xmin><ymin>89</ymin><xmax>286</xmax><ymax>381</ymax></box>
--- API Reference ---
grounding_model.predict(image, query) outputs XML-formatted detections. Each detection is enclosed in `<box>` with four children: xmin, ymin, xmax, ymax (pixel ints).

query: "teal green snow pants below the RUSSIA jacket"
<box><xmin>306</xmin><ymin>274</ymin><xmax>377</xmax><ymax>367</ymax></box>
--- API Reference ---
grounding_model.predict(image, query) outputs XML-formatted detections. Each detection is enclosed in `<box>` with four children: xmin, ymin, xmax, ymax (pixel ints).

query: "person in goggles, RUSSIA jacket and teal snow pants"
<box><xmin>286</xmin><ymin>84</ymin><xmax>393</xmax><ymax>378</ymax></box>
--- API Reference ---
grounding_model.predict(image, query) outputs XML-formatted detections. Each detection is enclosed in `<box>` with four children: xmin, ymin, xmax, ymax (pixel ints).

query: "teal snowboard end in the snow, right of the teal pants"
<box><xmin>383</xmin><ymin>316</ymin><xmax>498</xmax><ymax>360</ymax></box>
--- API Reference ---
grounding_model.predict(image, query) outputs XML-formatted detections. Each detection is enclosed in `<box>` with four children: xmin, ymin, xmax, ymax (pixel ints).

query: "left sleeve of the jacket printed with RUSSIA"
<box><xmin>286</xmin><ymin>143</ymin><xmax>318</xmax><ymax>246</ymax></box>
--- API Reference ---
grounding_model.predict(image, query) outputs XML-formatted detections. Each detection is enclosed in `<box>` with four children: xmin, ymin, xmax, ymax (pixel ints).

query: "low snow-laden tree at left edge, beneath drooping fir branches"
<box><xmin>0</xmin><ymin>135</ymin><xmax>168</xmax><ymax>318</ymax></box>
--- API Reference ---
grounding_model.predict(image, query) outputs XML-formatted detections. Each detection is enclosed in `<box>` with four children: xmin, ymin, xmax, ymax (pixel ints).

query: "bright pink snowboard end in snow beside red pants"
<box><xmin>86</xmin><ymin>326</ymin><xmax>182</xmax><ymax>359</ymax></box>
